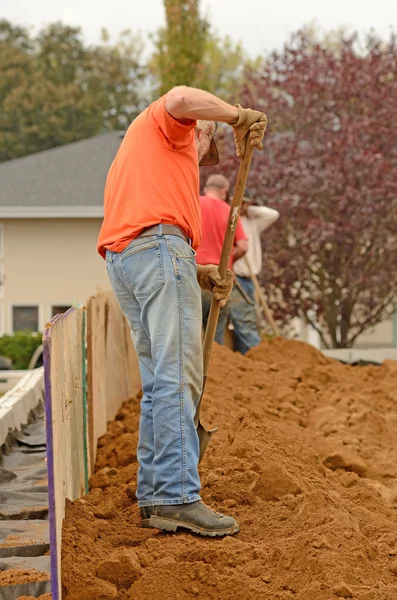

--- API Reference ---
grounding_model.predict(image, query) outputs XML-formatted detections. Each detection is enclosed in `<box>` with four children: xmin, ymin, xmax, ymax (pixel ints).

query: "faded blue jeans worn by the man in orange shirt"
<box><xmin>106</xmin><ymin>235</ymin><xmax>203</xmax><ymax>507</ymax></box>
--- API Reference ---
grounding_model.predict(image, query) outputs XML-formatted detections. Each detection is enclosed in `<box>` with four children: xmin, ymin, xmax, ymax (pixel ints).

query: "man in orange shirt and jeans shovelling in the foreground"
<box><xmin>98</xmin><ymin>86</ymin><xmax>266</xmax><ymax>536</ymax></box>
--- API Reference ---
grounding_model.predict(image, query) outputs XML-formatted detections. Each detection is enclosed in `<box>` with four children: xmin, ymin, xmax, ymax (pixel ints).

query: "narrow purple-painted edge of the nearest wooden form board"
<box><xmin>43</xmin><ymin>315</ymin><xmax>61</xmax><ymax>600</ymax></box>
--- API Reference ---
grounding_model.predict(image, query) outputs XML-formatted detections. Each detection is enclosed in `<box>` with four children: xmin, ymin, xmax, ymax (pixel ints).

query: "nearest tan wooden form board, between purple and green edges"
<box><xmin>44</xmin><ymin>308</ymin><xmax>88</xmax><ymax>600</ymax></box>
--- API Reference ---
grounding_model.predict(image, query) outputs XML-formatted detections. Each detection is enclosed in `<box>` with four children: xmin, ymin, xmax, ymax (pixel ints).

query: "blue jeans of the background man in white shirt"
<box><xmin>227</xmin><ymin>275</ymin><xmax>261</xmax><ymax>354</ymax></box>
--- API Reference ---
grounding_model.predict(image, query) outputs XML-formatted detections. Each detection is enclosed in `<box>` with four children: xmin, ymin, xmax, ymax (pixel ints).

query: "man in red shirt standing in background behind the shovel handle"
<box><xmin>196</xmin><ymin>175</ymin><xmax>248</xmax><ymax>344</ymax></box>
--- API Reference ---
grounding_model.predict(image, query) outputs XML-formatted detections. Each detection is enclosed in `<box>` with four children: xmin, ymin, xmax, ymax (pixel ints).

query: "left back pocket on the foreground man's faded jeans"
<box><xmin>119</xmin><ymin>238</ymin><xmax>164</xmax><ymax>298</ymax></box>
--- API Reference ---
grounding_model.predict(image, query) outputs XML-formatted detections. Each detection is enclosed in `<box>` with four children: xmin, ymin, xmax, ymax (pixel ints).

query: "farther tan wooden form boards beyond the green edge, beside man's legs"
<box><xmin>87</xmin><ymin>292</ymin><xmax>141</xmax><ymax>470</ymax></box>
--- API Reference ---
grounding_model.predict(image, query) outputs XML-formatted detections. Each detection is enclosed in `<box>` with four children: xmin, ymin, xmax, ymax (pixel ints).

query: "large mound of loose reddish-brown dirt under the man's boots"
<box><xmin>62</xmin><ymin>339</ymin><xmax>397</xmax><ymax>600</ymax></box>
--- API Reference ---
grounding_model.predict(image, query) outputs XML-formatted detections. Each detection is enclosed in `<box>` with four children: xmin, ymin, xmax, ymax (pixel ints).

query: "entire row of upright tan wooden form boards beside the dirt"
<box><xmin>44</xmin><ymin>292</ymin><xmax>141</xmax><ymax>600</ymax></box>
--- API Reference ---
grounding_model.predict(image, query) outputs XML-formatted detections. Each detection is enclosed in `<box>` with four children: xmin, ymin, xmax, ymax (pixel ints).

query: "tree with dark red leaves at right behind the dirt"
<box><xmin>222</xmin><ymin>33</ymin><xmax>397</xmax><ymax>348</ymax></box>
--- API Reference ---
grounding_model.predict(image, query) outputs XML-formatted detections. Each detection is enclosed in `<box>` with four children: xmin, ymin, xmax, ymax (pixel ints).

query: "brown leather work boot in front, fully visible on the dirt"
<box><xmin>149</xmin><ymin>500</ymin><xmax>240</xmax><ymax>537</ymax></box>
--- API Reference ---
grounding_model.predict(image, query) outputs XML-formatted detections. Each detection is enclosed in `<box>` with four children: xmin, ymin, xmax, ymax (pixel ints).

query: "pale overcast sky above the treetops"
<box><xmin>0</xmin><ymin>0</ymin><xmax>397</xmax><ymax>54</ymax></box>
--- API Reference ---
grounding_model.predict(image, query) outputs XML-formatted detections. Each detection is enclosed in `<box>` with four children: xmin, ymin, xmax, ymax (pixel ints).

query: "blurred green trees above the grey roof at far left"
<box><xmin>0</xmin><ymin>21</ymin><xmax>145</xmax><ymax>161</ymax></box>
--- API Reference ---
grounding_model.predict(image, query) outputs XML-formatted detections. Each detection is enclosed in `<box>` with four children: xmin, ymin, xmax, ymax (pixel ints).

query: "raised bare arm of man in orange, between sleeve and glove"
<box><xmin>165</xmin><ymin>86</ymin><xmax>238</xmax><ymax>124</ymax></box>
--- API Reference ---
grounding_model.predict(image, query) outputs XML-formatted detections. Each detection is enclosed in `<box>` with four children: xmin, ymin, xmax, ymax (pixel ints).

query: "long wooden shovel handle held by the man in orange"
<box><xmin>203</xmin><ymin>144</ymin><xmax>254</xmax><ymax>378</ymax></box>
